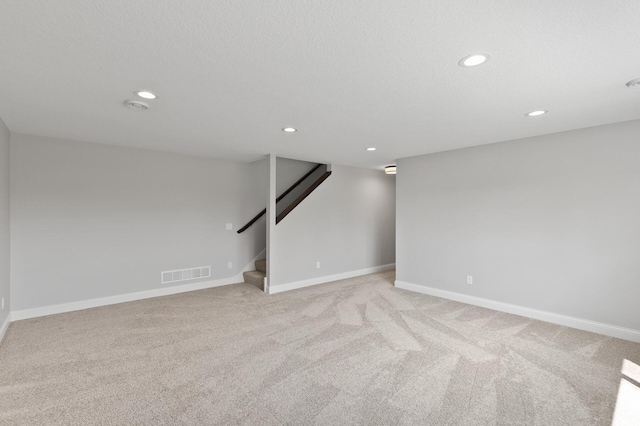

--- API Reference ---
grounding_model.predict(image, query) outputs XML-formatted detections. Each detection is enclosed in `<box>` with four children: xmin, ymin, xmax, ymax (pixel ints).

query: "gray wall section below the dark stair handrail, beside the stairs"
<box><xmin>270</xmin><ymin>165</ymin><xmax>395</xmax><ymax>289</ymax></box>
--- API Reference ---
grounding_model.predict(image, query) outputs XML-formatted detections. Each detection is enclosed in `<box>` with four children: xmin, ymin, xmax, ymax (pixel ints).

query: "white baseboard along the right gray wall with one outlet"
<box><xmin>395</xmin><ymin>281</ymin><xmax>640</xmax><ymax>343</ymax></box>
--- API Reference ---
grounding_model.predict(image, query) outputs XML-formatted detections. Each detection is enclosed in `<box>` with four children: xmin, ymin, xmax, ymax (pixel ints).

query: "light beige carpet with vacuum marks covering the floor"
<box><xmin>0</xmin><ymin>271</ymin><xmax>640</xmax><ymax>426</ymax></box>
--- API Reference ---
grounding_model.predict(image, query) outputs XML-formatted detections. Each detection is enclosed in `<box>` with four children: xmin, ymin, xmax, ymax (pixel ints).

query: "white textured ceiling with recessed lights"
<box><xmin>0</xmin><ymin>0</ymin><xmax>640</xmax><ymax>167</ymax></box>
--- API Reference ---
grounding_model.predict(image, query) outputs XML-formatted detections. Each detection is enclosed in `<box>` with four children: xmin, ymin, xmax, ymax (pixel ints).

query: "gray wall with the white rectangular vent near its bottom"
<box><xmin>11</xmin><ymin>134</ymin><xmax>266</xmax><ymax>311</ymax></box>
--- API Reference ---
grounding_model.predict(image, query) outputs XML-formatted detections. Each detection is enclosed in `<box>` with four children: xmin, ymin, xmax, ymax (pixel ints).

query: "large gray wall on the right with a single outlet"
<box><xmin>397</xmin><ymin>121</ymin><xmax>640</xmax><ymax>330</ymax></box>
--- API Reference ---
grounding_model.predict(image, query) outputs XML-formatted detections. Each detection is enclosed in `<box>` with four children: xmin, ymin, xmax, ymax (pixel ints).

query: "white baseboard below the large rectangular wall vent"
<box><xmin>11</xmin><ymin>273</ymin><xmax>243</xmax><ymax>321</ymax></box>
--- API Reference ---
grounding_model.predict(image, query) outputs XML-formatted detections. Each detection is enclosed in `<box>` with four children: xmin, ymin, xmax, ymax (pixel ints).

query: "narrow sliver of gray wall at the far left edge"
<box><xmin>0</xmin><ymin>119</ymin><xmax>11</xmax><ymax>326</ymax></box>
